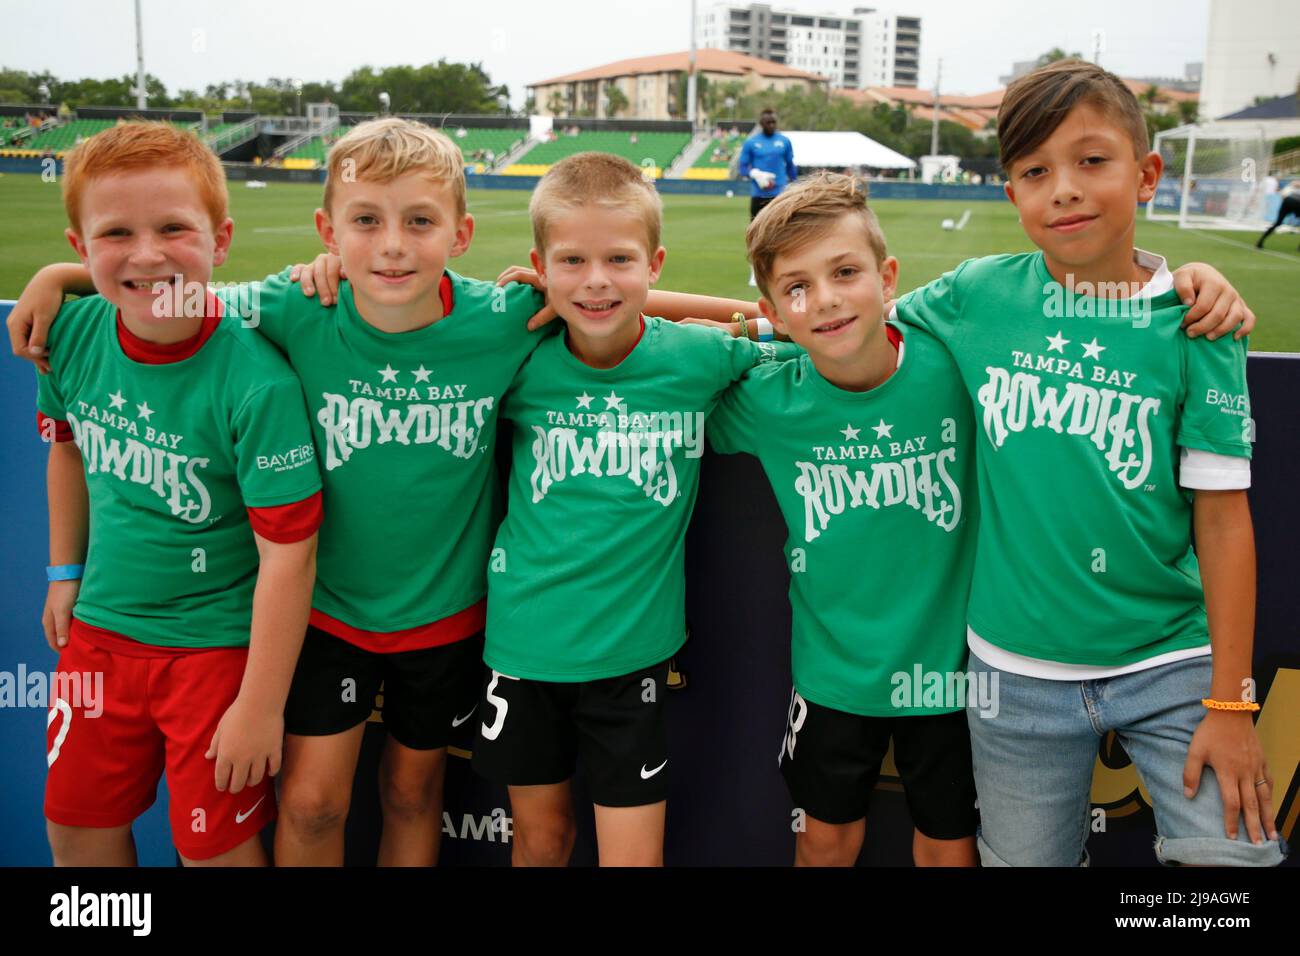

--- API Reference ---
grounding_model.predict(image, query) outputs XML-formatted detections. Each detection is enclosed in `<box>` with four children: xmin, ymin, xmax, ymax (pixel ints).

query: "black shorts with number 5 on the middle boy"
<box><xmin>475</xmin><ymin>661</ymin><xmax>668</xmax><ymax>806</ymax></box>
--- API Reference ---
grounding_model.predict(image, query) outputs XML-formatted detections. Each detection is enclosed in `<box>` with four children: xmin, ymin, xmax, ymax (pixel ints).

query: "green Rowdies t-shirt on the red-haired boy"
<box><xmin>36</xmin><ymin>295</ymin><xmax>321</xmax><ymax>648</ymax></box>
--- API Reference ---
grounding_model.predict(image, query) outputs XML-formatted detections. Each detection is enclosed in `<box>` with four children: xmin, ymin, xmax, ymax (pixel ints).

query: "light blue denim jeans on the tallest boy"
<box><xmin>966</xmin><ymin>653</ymin><xmax>1287</xmax><ymax>866</ymax></box>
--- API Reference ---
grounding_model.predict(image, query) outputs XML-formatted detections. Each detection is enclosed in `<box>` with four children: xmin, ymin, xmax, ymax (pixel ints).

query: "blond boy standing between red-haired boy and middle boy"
<box><xmin>19</xmin><ymin>118</ymin><xmax>542</xmax><ymax>865</ymax></box>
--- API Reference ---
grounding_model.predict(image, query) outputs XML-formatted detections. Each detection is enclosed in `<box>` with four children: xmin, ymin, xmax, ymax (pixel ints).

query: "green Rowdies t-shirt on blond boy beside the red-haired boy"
<box><xmin>222</xmin><ymin>269</ymin><xmax>546</xmax><ymax>632</ymax></box>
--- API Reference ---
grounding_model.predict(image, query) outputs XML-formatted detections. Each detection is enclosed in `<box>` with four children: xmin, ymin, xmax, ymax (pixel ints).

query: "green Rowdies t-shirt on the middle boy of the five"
<box><xmin>484</xmin><ymin>317</ymin><xmax>798</xmax><ymax>682</ymax></box>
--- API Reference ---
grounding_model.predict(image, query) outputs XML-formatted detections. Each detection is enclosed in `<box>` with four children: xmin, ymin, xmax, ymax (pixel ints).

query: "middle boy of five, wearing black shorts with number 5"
<box><xmin>462</xmin><ymin>153</ymin><xmax>790</xmax><ymax>865</ymax></box>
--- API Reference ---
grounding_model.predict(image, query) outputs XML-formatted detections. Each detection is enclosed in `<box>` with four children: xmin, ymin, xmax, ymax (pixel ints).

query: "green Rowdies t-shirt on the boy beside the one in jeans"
<box><xmin>709</xmin><ymin>329</ymin><xmax>978</xmax><ymax>717</ymax></box>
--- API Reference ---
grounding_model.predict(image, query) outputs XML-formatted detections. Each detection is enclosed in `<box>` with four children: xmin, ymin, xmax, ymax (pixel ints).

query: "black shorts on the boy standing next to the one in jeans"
<box><xmin>777</xmin><ymin>692</ymin><xmax>979</xmax><ymax>840</ymax></box>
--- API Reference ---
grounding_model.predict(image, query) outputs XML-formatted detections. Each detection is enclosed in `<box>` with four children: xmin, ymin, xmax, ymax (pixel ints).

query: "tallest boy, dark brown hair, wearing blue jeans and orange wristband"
<box><xmin>897</xmin><ymin>60</ymin><xmax>1286</xmax><ymax>865</ymax></box>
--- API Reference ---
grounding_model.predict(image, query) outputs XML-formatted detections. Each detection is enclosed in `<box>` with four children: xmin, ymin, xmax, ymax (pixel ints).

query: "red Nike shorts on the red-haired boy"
<box><xmin>46</xmin><ymin>620</ymin><xmax>276</xmax><ymax>860</ymax></box>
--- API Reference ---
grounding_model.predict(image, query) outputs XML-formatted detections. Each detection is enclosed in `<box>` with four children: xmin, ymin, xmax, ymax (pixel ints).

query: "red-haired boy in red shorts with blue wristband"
<box><xmin>36</xmin><ymin>122</ymin><xmax>321</xmax><ymax>866</ymax></box>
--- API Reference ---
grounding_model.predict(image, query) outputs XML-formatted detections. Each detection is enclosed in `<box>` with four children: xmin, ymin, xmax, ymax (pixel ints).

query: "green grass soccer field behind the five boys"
<box><xmin>0</xmin><ymin>174</ymin><xmax>1300</xmax><ymax>352</ymax></box>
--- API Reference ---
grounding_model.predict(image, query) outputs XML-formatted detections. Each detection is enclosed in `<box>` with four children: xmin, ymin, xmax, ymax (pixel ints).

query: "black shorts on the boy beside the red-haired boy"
<box><xmin>285</xmin><ymin>627</ymin><xmax>484</xmax><ymax>750</ymax></box>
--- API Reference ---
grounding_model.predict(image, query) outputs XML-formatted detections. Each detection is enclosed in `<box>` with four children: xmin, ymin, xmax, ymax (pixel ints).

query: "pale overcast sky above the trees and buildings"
<box><xmin>0</xmin><ymin>0</ymin><xmax>1206</xmax><ymax>108</ymax></box>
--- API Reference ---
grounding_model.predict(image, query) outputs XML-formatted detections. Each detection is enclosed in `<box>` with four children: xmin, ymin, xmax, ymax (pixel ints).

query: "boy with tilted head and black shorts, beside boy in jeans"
<box><xmin>709</xmin><ymin>174</ymin><xmax>989</xmax><ymax>866</ymax></box>
